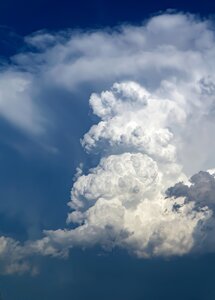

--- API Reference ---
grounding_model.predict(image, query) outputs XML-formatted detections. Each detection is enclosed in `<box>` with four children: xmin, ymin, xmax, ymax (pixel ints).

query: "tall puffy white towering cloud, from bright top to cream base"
<box><xmin>42</xmin><ymin>82</ymin><xmax>214</xmax><ymax>257</ymax></box>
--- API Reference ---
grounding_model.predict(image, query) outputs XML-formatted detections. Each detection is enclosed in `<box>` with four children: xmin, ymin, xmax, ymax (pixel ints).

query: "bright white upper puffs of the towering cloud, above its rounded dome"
<box><xmin>82</xmin><ymin>82</ymin><xmax>184</xmax><ymax>162</ymax></box>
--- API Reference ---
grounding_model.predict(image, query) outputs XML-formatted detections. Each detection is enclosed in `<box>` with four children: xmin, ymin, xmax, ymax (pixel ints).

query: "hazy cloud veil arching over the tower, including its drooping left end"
<box><xmin>0</xmin><ymin>14</ymin><xmax>215</xmax><ymax>151</ymax></box>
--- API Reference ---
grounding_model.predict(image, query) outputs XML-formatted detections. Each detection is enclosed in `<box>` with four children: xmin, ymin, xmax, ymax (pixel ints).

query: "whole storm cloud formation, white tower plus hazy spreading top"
<box><xmin>0</xmin><ymin>13</ymin><xmax>215</xmax><ymax>272</ymax></box>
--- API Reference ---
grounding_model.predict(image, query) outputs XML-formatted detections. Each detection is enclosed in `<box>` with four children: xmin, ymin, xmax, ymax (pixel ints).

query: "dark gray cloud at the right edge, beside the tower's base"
<box><xmin>166</xmin><ymin>170</ymin><xmax>215</xmax><ymax>252</ymax></box>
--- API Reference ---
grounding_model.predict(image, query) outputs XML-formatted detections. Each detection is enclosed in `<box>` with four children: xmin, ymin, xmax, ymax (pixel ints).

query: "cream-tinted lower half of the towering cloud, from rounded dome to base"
<box><xmin>62</xmin><ymin>153</ymin><xmax>210</xmax><ymax>257</ymax></box>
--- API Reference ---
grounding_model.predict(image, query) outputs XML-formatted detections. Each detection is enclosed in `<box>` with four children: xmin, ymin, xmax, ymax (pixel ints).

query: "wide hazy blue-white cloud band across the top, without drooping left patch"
<box><xmin>15</xmin><ymin>14</ymin><xmax>214</xmax><ymax>95</ymax></box>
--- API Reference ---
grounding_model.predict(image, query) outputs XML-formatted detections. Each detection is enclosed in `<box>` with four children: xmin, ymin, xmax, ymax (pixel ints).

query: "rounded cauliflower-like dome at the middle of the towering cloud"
<box><xmin>70</xmin><ymin>153</ymin><xmax>160</xmax><ymax>213</ymax></box>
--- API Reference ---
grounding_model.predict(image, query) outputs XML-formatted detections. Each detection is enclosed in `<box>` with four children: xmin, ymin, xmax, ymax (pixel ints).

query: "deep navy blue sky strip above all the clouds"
<box><xmin>0</xmin><ymin>0</ymin><xmax>214</xmax><ymax>34</ymax></box>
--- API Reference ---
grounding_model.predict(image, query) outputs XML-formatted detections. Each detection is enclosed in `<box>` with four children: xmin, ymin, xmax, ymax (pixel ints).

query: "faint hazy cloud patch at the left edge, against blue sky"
<box><xmin>0</xmin><ymin>68</ymin><xmax>45</xmax><ymax>134</ymax></box>
